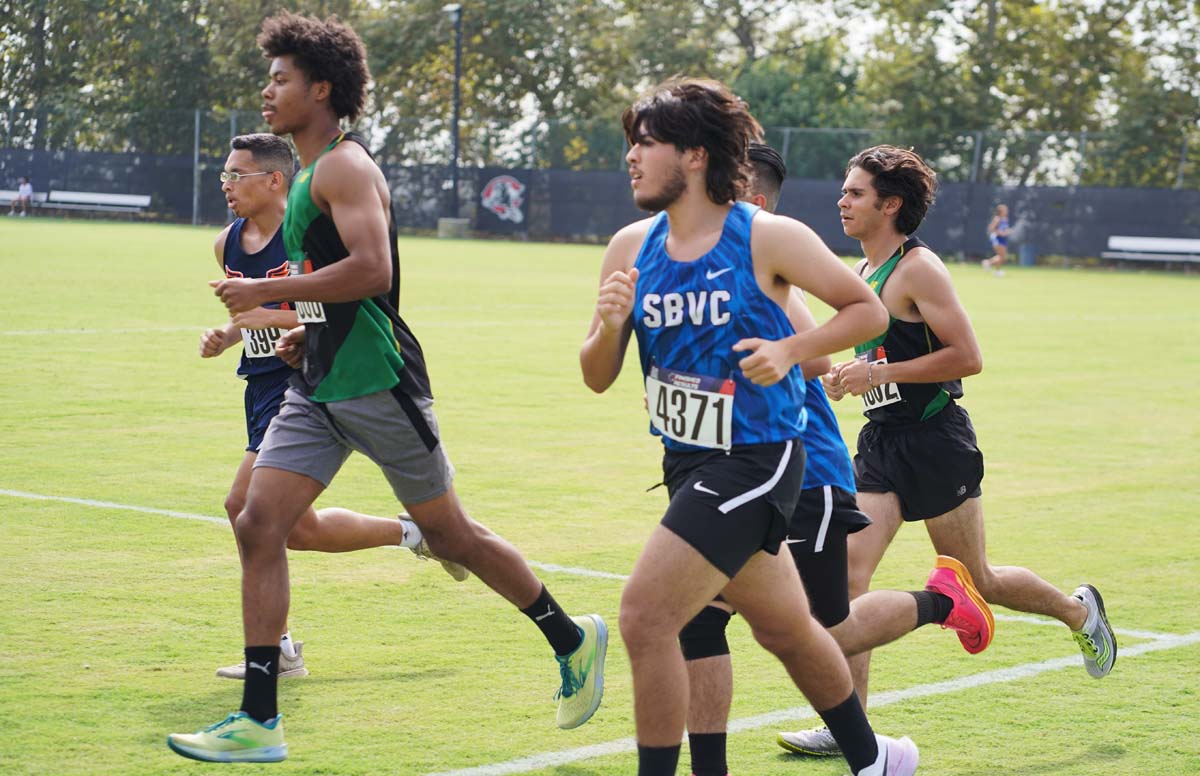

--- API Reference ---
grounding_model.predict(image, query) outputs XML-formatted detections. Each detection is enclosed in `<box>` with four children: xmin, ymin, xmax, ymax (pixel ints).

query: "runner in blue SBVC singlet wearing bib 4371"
<box><xmin>580</xmin><ymin>79</ymin><xmax>918</xmax><ymax>776</ymax></box>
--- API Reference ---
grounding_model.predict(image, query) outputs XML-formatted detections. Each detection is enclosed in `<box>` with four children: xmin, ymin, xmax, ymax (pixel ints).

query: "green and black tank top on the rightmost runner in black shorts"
<box><xmin>854</xmin><ymin>237</ymin><xmax>962</xmax><ymax>423</ymax></box>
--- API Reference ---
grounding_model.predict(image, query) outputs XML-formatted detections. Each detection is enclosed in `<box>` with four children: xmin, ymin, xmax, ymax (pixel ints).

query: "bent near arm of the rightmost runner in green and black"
<box><xmin>840</xmin><ymin>252</ymin><xmax>983</xmax><ymax>396</ymax></box>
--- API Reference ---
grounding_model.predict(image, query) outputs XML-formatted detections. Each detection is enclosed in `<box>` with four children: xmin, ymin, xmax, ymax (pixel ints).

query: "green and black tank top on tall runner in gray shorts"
<box><xmin>283</xmin><ymin>132</ymin><xmax>432</xmax><ymax>402</ymax></box>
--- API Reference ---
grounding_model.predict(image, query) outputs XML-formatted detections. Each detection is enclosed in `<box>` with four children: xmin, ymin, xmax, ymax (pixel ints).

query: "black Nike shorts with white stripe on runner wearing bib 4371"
<box><xmin>662</xmin><ymin>439</ymin><xmax>804</xmax><ymax>578</ymax></box>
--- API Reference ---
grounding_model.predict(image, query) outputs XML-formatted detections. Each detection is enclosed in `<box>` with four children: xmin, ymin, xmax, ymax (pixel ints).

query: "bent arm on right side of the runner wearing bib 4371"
<box><xmin>733</xmin><ymin>212</ymin><xmax>888</xmax><ymax>385</ymax></box>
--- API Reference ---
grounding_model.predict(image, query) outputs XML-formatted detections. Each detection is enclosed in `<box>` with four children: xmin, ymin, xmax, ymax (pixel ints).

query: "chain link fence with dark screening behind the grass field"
<box><xmin>0</xmin><ymin>107</ymin><xmax>1200</xmax><ymax>255</ymax></box>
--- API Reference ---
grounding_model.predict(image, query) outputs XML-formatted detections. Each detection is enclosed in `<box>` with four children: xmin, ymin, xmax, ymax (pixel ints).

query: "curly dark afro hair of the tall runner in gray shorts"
<box><xmin>258</xmin><ymin>11</ymin><xmax>371</xmax><ymax>121</ymax></box>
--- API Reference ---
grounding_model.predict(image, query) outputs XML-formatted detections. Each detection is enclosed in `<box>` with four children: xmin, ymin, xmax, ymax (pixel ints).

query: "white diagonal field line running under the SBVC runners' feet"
<box><xmin>428</xmin><ymin>631</ymin><xmax>1200</xmax><ymax>776</ymax></box>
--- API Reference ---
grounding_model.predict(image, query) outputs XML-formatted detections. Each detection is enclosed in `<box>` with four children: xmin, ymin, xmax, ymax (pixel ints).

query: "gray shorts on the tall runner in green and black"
<box><xmin>254</xmin><ymin>387</ymin><xmax>454</xmax><ymax>505</ymax></box>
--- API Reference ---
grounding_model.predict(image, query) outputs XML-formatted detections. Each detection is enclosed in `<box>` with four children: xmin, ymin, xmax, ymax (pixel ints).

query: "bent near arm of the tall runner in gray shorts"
<box><xmin>210</xmin><ymin>144</ymin><xmax>391</xmax><ymax>313</ymax></box>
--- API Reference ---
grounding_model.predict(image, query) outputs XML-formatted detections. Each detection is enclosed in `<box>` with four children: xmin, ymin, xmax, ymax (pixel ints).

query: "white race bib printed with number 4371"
<box><xmin>646</xmin><ymin>366</ymin><xmax>734</xmax><ymax>450</ymax></box>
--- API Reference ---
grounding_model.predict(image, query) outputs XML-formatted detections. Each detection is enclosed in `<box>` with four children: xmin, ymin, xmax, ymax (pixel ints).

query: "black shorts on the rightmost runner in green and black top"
<box><xmin>854</xmin><ymin>402</ymin><xmax>983</xmax><ymax>522</ymax></box>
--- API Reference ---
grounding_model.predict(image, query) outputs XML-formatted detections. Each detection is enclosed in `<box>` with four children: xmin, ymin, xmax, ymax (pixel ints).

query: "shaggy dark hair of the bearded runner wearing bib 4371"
<box><xmin>620</xmin><ymin>77</ymin><xmax>762</xmax><ymax>204</ymax></box>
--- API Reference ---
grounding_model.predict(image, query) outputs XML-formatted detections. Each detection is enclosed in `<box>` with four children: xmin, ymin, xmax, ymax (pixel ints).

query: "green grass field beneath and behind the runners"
<box><xmin>0</xmin><ymin>213</ymin><xmax>1200</xmax><ymax>776</ymax></box>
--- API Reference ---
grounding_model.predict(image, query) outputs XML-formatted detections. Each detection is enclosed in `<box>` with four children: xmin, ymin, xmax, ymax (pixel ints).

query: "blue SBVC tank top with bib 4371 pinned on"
<box><xmin>632</xmin><ymin>203</ymin><xmax>805</xmax><ymax>451</ymax></box>
